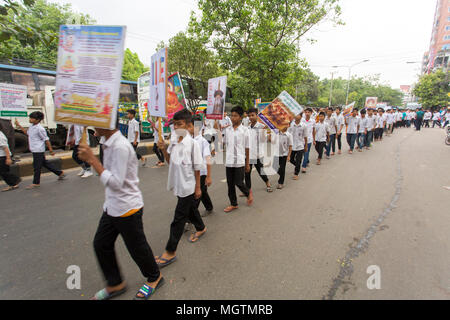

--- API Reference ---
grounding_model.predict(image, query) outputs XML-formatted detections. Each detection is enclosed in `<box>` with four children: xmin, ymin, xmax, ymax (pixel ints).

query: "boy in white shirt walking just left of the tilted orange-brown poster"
<box><xmin>245</xmin><ymin>108</ymin><xmax>273</xmax><ymax>193</ymax></box>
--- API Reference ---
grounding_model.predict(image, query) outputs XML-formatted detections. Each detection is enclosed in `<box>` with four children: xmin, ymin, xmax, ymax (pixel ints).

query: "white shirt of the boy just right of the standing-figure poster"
<box><xmin>224</xmin><ymin>125</ymin><xmax>250</xmax><ymax>168</ymax></box>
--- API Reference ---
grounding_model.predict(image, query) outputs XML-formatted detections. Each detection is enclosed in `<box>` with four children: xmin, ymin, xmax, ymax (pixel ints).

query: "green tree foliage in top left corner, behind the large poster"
<box><xmin>0</xmin><ymin>0</ymin><xmax>95</xmax><ymax>67</ymax></box>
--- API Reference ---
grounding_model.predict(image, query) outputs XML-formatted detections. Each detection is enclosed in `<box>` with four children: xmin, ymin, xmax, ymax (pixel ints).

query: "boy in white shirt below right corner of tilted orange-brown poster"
<box><xmin>289</xmin><ymin>113</ymin><xmax>308</xmax><ymax>180</ymax></box>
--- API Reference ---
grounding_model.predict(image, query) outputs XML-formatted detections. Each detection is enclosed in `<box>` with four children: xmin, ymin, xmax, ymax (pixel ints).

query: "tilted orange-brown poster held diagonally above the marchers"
<box><xmin>259</xmin><ymin>91</ymin><xmax>303</xmax><ymax>131</ymax></box>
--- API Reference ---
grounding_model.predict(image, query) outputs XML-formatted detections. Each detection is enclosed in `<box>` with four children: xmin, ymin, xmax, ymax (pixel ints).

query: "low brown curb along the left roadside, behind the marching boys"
<box><xmin>10</xmin><ymin>143</ymin><xmax>154</xmax><ymax>178</ymax></box>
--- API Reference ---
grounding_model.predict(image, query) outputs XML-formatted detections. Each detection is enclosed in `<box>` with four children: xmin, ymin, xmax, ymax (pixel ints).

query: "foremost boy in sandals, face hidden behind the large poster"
<box><xmin>78</xmin><ymin>124</ymin><xmax>164</xmax><ymax>300</ymax></box>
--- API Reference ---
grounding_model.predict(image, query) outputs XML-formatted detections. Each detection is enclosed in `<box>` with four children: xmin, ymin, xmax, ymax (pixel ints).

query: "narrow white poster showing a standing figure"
<box><xmin>206</xmin><ymin>76</ymin><xmax>227</xmax><ymax>120</ymax></box>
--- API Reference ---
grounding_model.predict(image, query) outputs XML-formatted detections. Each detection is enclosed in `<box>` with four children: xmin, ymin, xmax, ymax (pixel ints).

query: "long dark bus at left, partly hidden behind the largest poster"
<box><xmin>0</xmin><ymin>63</ymin><xmax>138</xmax><ymax>154</ymax></box>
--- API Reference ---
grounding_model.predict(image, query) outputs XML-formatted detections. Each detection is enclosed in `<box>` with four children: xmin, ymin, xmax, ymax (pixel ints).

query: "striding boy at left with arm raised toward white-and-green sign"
<box><xmin>16</xmin><ymin>111</ymin><xmax>66</xmax><ymax>190</ymax></box>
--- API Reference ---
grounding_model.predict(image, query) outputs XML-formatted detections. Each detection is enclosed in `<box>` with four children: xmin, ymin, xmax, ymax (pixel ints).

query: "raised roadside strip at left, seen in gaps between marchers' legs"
<box><xmin>10</xmin><ymin>142</ymin><xmax>159</xmax><ymax>177</ymax></box>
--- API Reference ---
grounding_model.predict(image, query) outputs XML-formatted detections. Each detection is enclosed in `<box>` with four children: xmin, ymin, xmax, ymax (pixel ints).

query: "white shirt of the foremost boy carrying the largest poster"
<box><xmin>100</xmin><ymin>131</ymin><xmax>144</xmax><ymax>217</ymax></box>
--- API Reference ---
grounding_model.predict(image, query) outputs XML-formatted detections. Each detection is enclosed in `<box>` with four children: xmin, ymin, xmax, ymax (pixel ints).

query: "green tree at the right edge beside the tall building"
<box><xmin>413</xmin><ymin>70</ymin><xmax>450</xmax><ymax>108</ymax></box>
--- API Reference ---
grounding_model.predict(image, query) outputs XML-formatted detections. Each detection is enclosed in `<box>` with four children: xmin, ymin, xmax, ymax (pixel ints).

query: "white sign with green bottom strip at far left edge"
<box><xmin>0</xmin><ymin>83</ymin><xmax>28</xmax><ymax>117</ymax></box>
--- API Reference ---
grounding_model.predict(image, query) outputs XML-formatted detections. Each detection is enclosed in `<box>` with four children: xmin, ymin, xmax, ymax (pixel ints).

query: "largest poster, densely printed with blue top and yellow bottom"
<box><xmin>55</xmin><ymin>25</ymin><xmax>126</xmax><ymax>129</ymax></box>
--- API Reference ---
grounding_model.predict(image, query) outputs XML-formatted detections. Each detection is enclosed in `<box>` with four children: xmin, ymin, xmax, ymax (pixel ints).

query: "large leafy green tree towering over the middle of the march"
<box><xmin>190</xmin><ymin>0</ymin><xmax>340</xmax><ymax>107</ymax></box>
